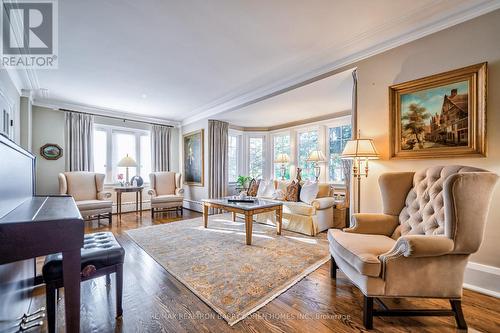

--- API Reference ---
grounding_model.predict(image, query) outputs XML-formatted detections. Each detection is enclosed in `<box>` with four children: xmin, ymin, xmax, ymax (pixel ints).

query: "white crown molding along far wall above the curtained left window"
<box><xmin>33</xmin><ymin>98</ymin><xmax>181</xmax><ymax>127</ymax></box>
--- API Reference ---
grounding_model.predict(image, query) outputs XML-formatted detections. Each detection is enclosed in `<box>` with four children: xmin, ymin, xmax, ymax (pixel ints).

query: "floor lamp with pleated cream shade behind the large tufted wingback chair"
<box><xmin>341</xmin><ymin>134</ymin><xmax>379</xmax><ymax>213</ymax></box>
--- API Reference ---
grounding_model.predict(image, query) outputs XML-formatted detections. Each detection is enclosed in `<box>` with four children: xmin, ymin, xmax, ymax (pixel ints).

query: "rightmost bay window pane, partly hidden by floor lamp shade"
<box><xmin>328</xmin><ymin>125</ymin><xmax>352</xmax><ymax>183</ymax></box>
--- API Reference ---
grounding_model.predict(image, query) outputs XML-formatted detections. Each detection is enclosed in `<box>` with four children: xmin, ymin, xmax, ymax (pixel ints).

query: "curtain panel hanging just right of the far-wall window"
<box><xmin>151</xmin><ymin>125</ymin><xmax>171</xmax><ymax>172</ymax></box>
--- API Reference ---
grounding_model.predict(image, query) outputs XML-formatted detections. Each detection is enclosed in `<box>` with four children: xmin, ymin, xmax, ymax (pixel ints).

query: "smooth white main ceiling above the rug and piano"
<box><xmin>19</xmin><ymin>0</ymin><xmax>500</xmax><ymax>123</ymax></box>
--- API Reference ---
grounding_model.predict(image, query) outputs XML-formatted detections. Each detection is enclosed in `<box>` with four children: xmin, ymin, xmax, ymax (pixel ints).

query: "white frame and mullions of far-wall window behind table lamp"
<box><xmin>94</xmin><ymin>124</ymin><xmax>151</xmax><ymax>186</ymax></box>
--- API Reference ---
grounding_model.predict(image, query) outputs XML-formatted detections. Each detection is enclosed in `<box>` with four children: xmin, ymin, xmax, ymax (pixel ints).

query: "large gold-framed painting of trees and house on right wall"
<box><xmin>389</xmin><ymin>63</ymin><xmax>487</xmax><ymax>159</ymax></box>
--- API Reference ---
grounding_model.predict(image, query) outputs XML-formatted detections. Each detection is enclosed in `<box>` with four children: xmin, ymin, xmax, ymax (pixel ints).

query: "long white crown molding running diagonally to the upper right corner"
<box><xmin>182</xmin><ymin>0</ymin><xmax>500</xmax><ymax>126</ymax></box>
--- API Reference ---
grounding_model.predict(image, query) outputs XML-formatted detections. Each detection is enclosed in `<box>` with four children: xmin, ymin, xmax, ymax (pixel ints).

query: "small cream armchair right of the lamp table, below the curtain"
<box><xmin>148</xmin><ymin>171</ymin><xmax>184</xmax><ymax>218</ymax></box>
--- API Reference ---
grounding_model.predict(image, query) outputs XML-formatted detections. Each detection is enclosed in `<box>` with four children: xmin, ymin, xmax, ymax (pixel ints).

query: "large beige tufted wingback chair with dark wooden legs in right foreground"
<box><xmin>328</xmin><ymin>166</ymin><xmax>498</xmax><ymax>329</ymax></box>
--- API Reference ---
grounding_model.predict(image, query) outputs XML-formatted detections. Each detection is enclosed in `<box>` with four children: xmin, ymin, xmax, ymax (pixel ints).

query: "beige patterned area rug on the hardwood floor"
<box><xmin>127</xmin><ymin>214</ymin><xmax>330</xmax><ymax>325</ymax></box>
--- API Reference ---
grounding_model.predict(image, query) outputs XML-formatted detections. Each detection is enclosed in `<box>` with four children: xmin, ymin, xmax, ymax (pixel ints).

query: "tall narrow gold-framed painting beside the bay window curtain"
<box><xmin>183</xmin><ymin>129</ymin><xmax>204</xmax><ymax>186</ymax></box>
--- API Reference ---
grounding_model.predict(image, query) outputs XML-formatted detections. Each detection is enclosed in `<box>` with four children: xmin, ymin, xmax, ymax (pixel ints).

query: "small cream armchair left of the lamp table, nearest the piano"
<box><xmin>59</xmin><ymin>171</ymin><xmax>113</xmax><ymax>226</ymax></box>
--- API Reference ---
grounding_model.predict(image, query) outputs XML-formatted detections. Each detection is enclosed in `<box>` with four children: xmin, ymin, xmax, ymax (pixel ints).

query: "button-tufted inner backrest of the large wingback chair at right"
<box><xmin>392</xmin><ymin>165</ymin><xmax>485</xmax><ymax>239</ymax></box>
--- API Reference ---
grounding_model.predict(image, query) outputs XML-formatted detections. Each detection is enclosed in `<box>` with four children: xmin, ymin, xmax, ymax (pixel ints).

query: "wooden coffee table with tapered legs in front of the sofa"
<box><xmin>203</xmin><ymin>198</ymin><xmax>283</xmax><ymax>245</ymax></box>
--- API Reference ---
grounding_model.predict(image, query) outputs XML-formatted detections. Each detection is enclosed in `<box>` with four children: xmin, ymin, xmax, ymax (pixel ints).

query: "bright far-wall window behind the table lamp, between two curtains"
<box><xmin>94</xmin><ymin>125</ymin><xmax>151</xmax><ymax>184</ymax></box>
